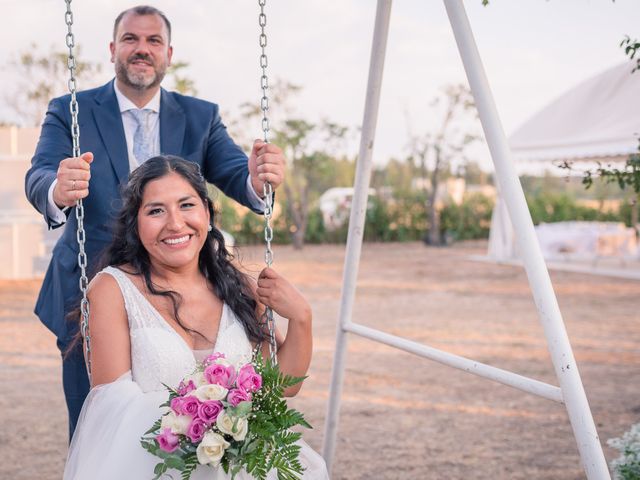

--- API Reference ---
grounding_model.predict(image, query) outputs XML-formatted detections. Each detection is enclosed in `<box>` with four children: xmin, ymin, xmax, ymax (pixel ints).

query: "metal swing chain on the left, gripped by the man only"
<box><xmin>64</xmin><ymin>0</ymin><xmax>91</xmax><ymax>381</ymax></box>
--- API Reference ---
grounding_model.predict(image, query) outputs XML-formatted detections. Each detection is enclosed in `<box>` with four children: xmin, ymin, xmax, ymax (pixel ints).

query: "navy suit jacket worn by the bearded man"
<box><xmin>25</xmin><ymin>81</ymin><xmax>255</xmax><ymax>348</ymax></box>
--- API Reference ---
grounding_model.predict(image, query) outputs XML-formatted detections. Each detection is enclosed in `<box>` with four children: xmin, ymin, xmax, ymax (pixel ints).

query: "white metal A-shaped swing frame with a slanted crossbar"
<box><xmin>323</xmin><ymin>0</ymin><xmax>611</xmax><ymax>480</ymax></box>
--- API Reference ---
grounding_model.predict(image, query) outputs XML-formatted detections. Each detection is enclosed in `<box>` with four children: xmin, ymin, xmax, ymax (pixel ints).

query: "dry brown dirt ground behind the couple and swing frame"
<box><xmin>0</xmin><ymin>243</ymin><xmax>640</xmax><ymax>480</ymax></box>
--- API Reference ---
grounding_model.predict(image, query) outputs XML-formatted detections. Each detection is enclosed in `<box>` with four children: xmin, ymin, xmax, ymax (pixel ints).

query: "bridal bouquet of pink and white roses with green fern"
<box><xmin>140</xmin><ymin>353</ymin><xmax>311</xmax><ymax>480</ymax></box>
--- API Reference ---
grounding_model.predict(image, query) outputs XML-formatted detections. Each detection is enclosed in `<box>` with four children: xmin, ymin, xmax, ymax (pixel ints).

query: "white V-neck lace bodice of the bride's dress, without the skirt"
<box><xmin>100</xmin><ymin>267</ymin><xmax>252</xmax><ymax>392</ymax></box>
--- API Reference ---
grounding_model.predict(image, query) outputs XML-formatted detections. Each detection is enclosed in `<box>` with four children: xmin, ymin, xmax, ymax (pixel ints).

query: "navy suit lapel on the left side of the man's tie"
<box><xmin>93</xmin><ymin>81</ymin><xmax>129</xmax><ymax>183</ymax></box>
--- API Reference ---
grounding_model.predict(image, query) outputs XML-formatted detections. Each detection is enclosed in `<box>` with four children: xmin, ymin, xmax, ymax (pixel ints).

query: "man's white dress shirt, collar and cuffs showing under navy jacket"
<box><xmin>47</xmin><ymin>82</ymin><xmax>266</xmax><ymax>225</ymax></box>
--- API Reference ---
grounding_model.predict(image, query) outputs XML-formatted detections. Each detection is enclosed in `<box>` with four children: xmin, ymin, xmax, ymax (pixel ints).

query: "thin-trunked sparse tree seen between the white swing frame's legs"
<box><xmin>409</xmin><ymin>85</ymin><xmax>479</xmax><ymax>245</ymax></box>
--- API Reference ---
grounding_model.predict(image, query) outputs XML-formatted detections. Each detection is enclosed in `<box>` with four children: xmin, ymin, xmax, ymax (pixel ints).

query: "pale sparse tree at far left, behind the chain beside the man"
<box><xmin>4</xmin><ymin>43</ymin><xmax>102</xmax><ymax>126</ymax></box>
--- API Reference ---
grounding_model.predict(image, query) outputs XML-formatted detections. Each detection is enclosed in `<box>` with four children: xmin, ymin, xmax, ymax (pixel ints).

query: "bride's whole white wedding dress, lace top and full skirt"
<box><xmin>64</xmin><ymin>267</ymin><xmax>328</xmax><ymax>480</ymax></box>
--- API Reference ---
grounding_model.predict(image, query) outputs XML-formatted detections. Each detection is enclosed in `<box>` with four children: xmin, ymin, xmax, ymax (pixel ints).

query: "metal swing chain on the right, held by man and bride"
<box><xmin>258</xmin><ymin>0</ymin><xmax>278</xmax><ymax>364</ymax></box>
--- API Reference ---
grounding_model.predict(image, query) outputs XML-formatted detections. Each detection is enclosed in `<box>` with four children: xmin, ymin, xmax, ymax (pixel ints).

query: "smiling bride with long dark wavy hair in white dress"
<box><xmin>64</xmin><ymin>156</ymin><xmax>328</xmax><ymax>480</ymax></box>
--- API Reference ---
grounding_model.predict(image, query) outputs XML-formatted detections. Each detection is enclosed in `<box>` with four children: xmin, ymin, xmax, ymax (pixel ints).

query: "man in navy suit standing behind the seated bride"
<box><xmin>25</xmin><ymin>6</ymin><xmax>285</xmax><ymax>437</ymax></box>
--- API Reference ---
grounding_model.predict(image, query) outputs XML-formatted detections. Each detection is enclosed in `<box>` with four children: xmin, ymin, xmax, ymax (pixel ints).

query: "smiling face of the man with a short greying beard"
<box><xmin>109</xmin><ymin>13</ymin><xmax>173</xmax><ymax>90</ymax></box>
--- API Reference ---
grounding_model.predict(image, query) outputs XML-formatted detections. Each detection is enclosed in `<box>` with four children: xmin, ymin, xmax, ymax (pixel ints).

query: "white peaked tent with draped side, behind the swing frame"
<box><xmin>488</xmin><ymin>62</ymin><xmax>640</xmax><ymax>261</ymax></box>
